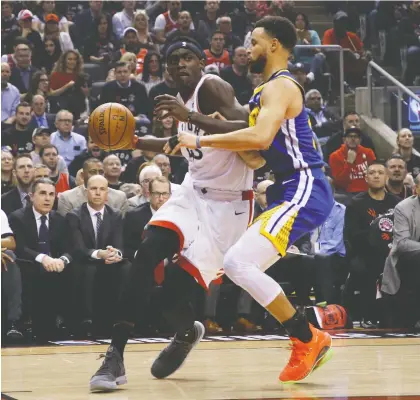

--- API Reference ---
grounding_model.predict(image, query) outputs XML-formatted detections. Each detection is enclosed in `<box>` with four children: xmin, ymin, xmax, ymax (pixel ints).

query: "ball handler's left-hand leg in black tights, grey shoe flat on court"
<box><xmin>90</xmin><ymin>226</ymin><xmax>179</xmax><ymax>391</ymax></box>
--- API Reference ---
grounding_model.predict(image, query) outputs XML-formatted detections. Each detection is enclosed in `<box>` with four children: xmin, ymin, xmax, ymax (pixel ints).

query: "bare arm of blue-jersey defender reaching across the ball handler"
<box><xmin>175</xmin><ymin>79</ymin><xmax>303</xmax><ymax>151</ymax></box>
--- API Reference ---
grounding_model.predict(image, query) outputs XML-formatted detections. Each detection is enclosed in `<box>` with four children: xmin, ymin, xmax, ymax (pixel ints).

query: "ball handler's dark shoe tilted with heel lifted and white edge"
<box><xmin>151</xmin><ymin>321</ymin><xmax>206</xmax><ymax>379</ymax></box>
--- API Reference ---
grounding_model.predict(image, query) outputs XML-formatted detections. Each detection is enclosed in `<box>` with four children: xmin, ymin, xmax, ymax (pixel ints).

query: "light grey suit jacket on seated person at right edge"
<box><xmin>381</xmin><ymin>196</ymin><xmax>420</xmax><ymax>294</ymax></box>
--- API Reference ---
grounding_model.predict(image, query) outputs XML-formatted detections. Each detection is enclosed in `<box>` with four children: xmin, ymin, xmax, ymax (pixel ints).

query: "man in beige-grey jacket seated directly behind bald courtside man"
<box><xmin>57</xmin><ymin>158</ymin><xmax>128</xmax><ymax>216</ymax></box>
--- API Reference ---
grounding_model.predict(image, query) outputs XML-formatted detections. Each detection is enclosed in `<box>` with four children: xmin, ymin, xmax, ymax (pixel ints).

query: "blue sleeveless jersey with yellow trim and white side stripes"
<box><xmin>249</xmin><ymin>70</ymin><xmax>324</xmax><ymax>175</ymax></box>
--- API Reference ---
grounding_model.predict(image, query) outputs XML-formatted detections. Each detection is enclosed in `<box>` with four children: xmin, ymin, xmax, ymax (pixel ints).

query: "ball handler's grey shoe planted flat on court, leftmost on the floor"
<box><xmin>89</xmin><ymin>346</ymin><xmax>127</xmax><ymax>392</ymax></box>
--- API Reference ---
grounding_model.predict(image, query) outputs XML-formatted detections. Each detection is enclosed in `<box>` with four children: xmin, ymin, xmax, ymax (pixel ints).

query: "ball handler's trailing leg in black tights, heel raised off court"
<box><xmin>151</xmin><ymin>265</ymin><xmax>205</xmax><ymax>379</ymax></box>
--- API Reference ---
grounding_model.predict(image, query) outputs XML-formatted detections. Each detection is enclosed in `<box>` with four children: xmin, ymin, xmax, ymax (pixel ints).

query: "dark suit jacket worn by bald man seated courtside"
<box><xmin>66</xmin><ymin>203</ymin><xmax>123</xmax><ymax>261</ymax></box>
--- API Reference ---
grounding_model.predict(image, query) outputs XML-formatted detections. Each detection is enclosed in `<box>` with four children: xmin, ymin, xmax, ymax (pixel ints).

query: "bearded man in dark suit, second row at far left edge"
<box><xmin>1</xmin><ymin>154</ymin><xmax>34</xmax><ymax>216</ymax></box>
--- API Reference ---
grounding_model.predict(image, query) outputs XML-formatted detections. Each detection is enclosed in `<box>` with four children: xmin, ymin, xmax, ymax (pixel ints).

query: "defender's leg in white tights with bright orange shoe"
<box><xmin>224</xmin><ymin>221</ymin><xmax>331</xmax><ymax>382</ymax></box>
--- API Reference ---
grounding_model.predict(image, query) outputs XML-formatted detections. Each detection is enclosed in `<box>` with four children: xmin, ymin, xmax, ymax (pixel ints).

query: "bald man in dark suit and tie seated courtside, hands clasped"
<box><xmin>66</xmin><ymin>175</ymin><xmax>131</xmax><ymax>333</ymax></box>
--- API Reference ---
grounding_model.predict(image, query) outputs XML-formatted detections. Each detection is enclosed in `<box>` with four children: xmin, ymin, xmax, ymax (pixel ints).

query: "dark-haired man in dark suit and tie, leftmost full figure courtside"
<box><xmin>9</xmin><ymin>178</ymin><xmax>72</xmax><ymax>340</ymax></box>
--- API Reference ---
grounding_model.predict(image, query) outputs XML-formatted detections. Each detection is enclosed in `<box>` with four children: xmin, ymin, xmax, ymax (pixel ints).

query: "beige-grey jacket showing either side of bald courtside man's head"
<box><xmin>57</xmin><ymin>185</ymin><xmax>128</xmax><ymax>217</ymax></box>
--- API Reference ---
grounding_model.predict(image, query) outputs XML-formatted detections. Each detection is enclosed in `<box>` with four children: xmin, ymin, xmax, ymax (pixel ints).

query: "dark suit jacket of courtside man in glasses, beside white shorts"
<box><xmin>124</xmin><ymin>203</ymin><xmax>152</xmax><ymax>261</ymax></box>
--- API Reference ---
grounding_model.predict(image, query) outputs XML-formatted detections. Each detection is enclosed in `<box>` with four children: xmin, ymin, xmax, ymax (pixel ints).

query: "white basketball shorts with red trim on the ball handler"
<box><xmin>148</xmin><ymin>185</ymin><xmax>254</xmax><ymax>289</ymax></box>
